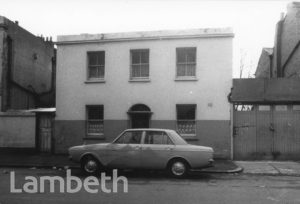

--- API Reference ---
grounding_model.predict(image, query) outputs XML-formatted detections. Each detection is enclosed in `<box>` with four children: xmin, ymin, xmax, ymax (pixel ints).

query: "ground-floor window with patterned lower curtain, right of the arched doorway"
<box><xmin>176</xmin><ymin>104</ymin><xmax>197</xmax><ymax>136</ymax></box>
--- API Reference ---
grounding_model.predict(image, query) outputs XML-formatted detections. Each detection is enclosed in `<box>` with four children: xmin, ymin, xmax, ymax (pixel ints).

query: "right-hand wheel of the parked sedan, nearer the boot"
<box><xmin>168</xmin><ymin>159</ymin><xmax>189</xmax><ymax>178</ymax></box>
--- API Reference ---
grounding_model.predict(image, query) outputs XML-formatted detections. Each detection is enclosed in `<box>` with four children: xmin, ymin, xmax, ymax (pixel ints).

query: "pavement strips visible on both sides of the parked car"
<box><xmin>0</xmin><ymin>152</ymin><xmax>300</xmax><ymax>176</ymax></box>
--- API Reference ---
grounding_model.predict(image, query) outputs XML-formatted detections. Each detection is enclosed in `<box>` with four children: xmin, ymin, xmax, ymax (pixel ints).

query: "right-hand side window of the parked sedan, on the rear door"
<box><xmin>145</xmin><ymin>131</ymin><xmax>173</xmax><ymax>145</ymax></box>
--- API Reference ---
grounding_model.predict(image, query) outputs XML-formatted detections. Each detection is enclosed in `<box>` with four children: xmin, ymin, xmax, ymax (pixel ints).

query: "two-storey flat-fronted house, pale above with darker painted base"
<box><xmin>54</xmin><ymin>28</ymin><xmax>233</xmax><ymax>158</ymax></box>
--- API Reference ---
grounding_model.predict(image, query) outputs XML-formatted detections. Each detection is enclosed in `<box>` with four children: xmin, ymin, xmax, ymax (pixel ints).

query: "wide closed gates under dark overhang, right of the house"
<box><xmin>233</xmin><ymin>105</ymin><xmax>300</xmax><ymax>160</ymax></box>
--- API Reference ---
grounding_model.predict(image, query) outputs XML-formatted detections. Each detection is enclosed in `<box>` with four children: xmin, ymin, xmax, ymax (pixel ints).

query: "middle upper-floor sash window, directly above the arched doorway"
<box><xmin>130</xmin><ymin>49</ymin><xmax>149</xmax><ymax>79</ymax></box>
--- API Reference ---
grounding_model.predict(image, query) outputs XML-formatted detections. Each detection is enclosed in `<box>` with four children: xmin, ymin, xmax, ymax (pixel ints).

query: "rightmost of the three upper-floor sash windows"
<box><xmin>176</xmin><ymin>47</ymin><xmax>196</xmax><ymax>77</ymax></box>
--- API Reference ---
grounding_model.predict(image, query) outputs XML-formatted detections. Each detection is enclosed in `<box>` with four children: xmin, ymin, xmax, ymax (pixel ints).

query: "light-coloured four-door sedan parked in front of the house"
<box><xmin>69</xmin><ymin>129</ymin><xmax>213</xmax><ymax>177</ymax></box>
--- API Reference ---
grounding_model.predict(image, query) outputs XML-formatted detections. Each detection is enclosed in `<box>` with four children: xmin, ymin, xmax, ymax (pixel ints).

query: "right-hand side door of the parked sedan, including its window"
<box><xmin>141</xmin><ymin>131</ymin><xmax>175</xmax><ymax>169</ymax></box>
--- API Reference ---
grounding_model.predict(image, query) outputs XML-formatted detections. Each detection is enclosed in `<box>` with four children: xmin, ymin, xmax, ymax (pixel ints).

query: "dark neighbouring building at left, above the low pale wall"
<box><xmin>0</xmin><ymin>16</ymin><xmax>55</xmax><ymax>112</ymax></box>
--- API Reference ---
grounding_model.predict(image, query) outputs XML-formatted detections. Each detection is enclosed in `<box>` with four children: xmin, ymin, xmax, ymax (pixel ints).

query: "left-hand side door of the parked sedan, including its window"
<box><xmin>107</xmin><ymin>131</ymin><xmax>143</xmax><ymax>169</ymax></box>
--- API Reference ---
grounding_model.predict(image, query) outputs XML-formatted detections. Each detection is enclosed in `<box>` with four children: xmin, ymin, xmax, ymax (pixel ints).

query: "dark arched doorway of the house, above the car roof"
<box><xmin>128</xmin><ymin>104</ymin><xmax>152</xmax><ymax>128</ymax></box>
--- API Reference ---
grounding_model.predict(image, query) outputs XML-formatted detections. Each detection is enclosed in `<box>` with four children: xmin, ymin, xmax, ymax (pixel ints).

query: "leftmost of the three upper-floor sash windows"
<box><xmin>87</xmin><ymin>51</ymin><xmax>105</xmax><ymax>80</ymax></box>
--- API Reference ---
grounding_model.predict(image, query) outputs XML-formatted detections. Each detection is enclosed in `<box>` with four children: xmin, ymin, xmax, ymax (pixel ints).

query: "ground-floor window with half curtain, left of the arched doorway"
<box><xmin>86</xmin><ymin>105</ymin><xmax>104</xmax><ymax>136</ymax></box>
